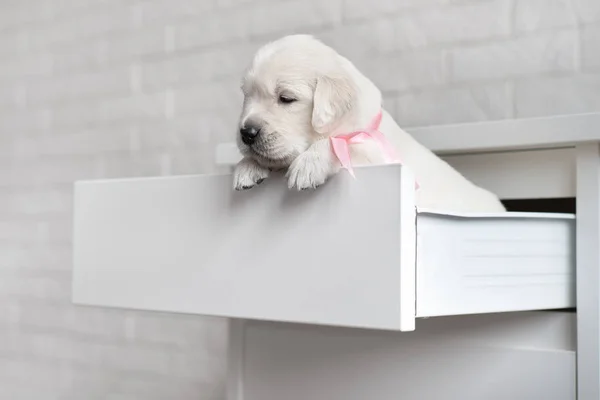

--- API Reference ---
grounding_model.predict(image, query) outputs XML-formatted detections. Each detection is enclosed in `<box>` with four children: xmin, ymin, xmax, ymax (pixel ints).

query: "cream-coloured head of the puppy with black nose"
<box><xmin>237</xmin><ymin>35</ymin><xmax>379</xmax><ymax>168</ymax></box>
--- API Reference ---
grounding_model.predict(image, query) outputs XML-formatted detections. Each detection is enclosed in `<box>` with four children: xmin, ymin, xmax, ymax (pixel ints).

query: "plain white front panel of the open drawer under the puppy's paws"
<box><xmin>73</xmin><ymin>165</ymin><xmax>415</xmax><ymax>330</ymax></box>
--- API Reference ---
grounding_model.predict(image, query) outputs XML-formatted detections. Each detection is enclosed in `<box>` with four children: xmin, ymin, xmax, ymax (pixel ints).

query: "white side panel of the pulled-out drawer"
<box><xmin>417</xmin><ymin>214</ymin><xmax>575</xmax><ymax>317</ymax></box>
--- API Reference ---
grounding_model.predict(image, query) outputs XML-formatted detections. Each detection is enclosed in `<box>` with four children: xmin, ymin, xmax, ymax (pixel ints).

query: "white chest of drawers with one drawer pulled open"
<box><xmin>73</xmin><ymin>113</ymin><xmax>600</xmax><ymax>400</ymax></box>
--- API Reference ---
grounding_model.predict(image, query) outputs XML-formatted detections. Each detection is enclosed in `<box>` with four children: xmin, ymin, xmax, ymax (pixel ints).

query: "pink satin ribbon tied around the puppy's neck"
<box><xmin>329</xmin><ymin>111</ymin><xmax>419</xmax><ymax>188</ymax></box>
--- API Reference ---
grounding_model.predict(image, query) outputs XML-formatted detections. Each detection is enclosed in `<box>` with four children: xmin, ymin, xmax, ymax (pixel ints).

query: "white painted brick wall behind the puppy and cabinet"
<box><xmin>0</xmin><ymin>0</ymin><xmax>600</xmax><ymax>400</ymax></box>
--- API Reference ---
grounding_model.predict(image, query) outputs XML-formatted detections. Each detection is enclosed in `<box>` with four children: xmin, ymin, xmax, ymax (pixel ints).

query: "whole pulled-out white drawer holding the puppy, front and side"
<box><xmin>73</xmin><ymin>165</ymin><xmax>575</xmax><ymax>331</ymax></box>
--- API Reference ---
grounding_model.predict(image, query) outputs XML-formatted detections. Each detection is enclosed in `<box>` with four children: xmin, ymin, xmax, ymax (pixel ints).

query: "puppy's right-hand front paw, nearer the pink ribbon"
<box><xmin>286</xmin><ymin>151</ymin><xmax>329</xmax><ymax>190</ymax></box>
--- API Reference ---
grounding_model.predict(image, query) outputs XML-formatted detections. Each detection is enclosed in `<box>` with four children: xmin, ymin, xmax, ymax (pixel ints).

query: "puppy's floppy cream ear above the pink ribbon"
<box><xmin>312</xmin><ymin>75</ymin><xmax>357</xmax><ymax>133</ymax></box>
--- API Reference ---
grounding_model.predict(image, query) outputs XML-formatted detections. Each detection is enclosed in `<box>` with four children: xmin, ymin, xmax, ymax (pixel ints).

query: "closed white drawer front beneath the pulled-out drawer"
<box><xmin>243</xmin><ymin>312</ymin><xmax>577</xmax><ymax>400</ymax></box>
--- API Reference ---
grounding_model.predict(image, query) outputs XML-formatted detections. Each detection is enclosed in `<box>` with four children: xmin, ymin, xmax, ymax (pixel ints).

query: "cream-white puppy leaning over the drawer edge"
<box><xmin>234</xmin><ymin>35</ymin><xmax>504</xmax><ymax>212</ymax></box>
